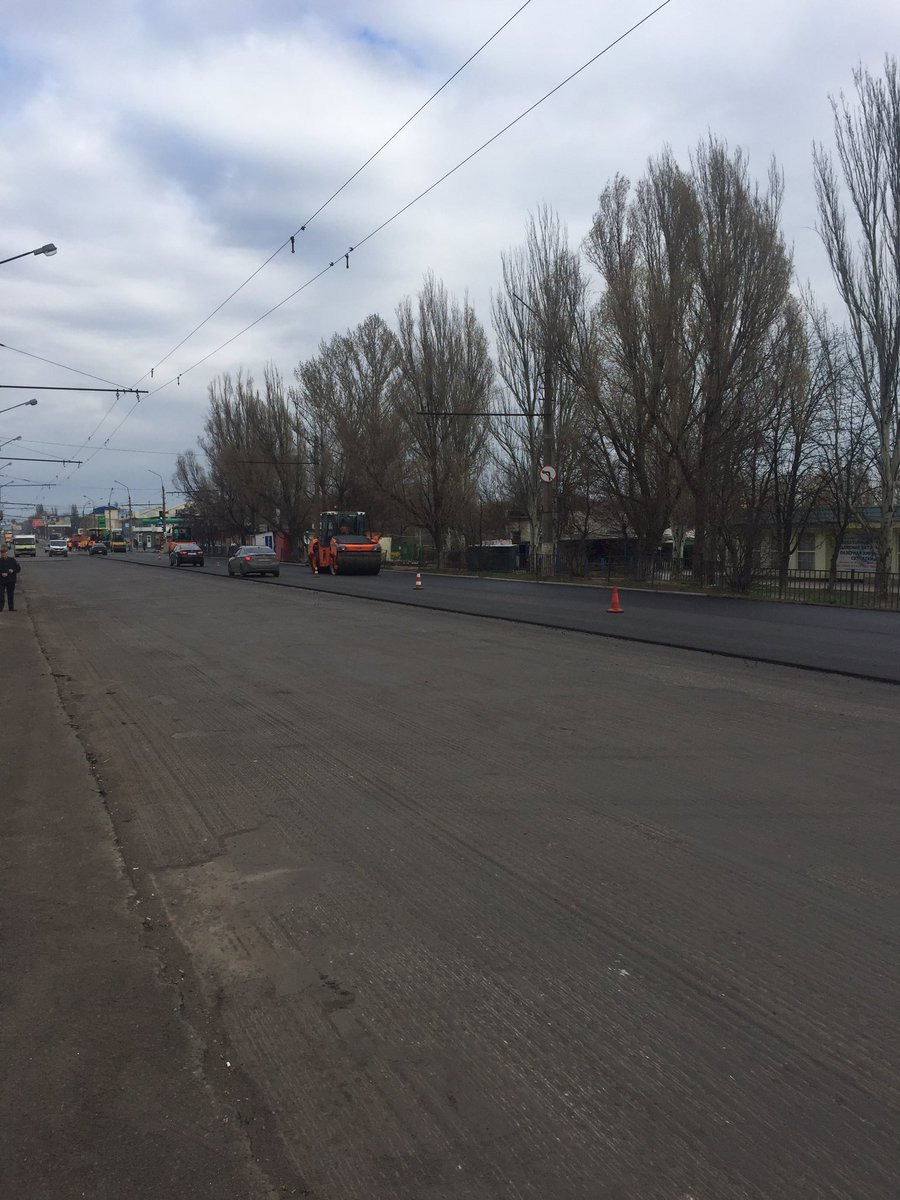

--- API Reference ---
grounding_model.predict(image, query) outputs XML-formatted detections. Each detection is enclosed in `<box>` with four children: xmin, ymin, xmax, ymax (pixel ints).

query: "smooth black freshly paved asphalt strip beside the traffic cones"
<box><xmin>123</xmin><ymin>553</ymin><xmax>900</xmax><ymax>683</ymax></box>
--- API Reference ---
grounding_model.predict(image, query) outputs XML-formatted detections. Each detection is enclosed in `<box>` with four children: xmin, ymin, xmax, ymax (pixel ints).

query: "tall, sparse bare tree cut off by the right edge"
<box><xmin>814</xmin><ymin>56</ymin><xmax>900</xmax><ymax>587</ymax></box>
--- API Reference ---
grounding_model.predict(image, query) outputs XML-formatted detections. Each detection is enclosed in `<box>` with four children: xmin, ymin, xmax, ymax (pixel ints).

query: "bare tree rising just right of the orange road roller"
<box><xmin>396</xmin><ymin>275</ymin><xmax>493</xmax><ymax>565</ymax></box>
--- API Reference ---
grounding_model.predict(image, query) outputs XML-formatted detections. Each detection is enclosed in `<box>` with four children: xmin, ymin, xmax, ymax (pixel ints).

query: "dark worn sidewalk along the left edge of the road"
<box><xmin>0</xmin><ymin>588</ymin><xmax>276</xmax><ymax>1200</ymax></box>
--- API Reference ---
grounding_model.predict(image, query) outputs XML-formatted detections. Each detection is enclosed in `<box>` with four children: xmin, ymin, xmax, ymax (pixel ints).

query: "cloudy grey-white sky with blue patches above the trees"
<box><xmin>0</xmin><ymin>0</ymin><xmax>900</xmax><ymax>514</ymax></box>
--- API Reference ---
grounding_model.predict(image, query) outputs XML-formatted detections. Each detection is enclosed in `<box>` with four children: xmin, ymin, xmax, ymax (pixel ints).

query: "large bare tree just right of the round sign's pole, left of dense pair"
<box><xmin>578</xmin><ymin>152</ymin><xmax>697</xmax><ymax>574</ymax></box>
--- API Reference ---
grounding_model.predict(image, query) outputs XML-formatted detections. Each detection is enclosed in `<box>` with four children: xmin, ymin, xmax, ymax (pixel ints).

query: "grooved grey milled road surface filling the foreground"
<box><xmin>23</xmin><ymin>558</ymin><xmax>900</xmax><ymax>1200</ymax></box>
